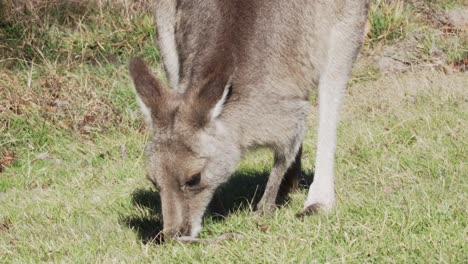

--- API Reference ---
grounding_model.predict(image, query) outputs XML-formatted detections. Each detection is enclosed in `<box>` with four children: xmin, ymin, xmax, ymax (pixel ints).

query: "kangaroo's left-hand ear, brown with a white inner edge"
<box><xmin>129</xmin><ymin>58</ymin><xmax>171</xmax><ymax>128</ymax></box>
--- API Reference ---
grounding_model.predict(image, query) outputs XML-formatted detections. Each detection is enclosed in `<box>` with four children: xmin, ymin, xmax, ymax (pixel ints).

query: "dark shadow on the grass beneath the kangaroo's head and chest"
<box><xmin>122</xmin><ymin>168</ymin><xmax>313</xmax><ymax>244</ymax></box>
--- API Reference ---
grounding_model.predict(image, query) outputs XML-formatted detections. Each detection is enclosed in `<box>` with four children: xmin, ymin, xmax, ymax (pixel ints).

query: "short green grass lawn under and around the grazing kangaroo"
<box><xmin>0</xmin><ymin>68</ymin><xmax>468</xmax><ymax>262</ymax></box>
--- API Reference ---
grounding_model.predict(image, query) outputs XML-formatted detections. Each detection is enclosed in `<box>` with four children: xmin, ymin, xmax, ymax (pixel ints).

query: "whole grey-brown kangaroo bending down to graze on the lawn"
<box><xmin>130</xmin><ymin>0</ymin><xmax>369</xmax><ymax>238</ymax></box>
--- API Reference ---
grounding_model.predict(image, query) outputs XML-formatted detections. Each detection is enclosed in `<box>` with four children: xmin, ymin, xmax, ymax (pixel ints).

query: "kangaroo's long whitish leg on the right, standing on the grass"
<box><xmin>304</xmin><ymin>14</ymin><xmax>363</xmax><ymax>213</ymax></box>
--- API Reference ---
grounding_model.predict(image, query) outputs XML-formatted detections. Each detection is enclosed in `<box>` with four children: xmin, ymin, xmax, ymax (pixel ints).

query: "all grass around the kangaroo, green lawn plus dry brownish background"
<box><xmin>0</xmin><ymin>1</ymin><xmax>468</xmax><ymax>263</ymax></box>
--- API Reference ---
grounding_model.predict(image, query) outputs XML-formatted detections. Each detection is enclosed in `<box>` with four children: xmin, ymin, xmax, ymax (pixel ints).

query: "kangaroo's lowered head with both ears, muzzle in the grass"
<box><xmin>130</xmin><ymin>59</ymin><xmax>240</xmax><ymax>237</ymax></box>
